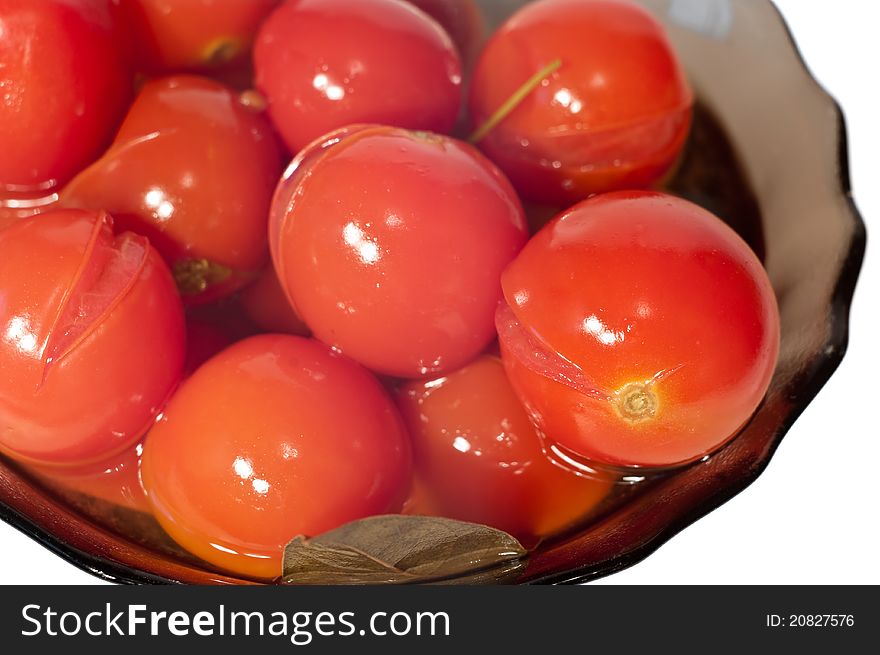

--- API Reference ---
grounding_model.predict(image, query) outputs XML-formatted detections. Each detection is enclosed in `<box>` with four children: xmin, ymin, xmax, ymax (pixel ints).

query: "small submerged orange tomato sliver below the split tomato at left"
<box><xmin>28</xmin><ymin>440</ymin><xmax>151</xmax><ymax>514</ymax></box>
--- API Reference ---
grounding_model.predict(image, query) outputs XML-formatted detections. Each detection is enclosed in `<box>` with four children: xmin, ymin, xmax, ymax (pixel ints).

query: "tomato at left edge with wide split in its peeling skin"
<box><xmin>0</xmin><ymin>210</ymin><xmax>184</xmax><ymax>466</ymax></box>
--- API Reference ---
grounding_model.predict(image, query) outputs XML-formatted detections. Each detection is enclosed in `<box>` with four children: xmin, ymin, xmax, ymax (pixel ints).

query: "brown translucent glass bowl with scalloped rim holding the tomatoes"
<box><xmin>0</xmin><ymin>0</ymin><xmax>865</xmax><ymax>583</ymax></box>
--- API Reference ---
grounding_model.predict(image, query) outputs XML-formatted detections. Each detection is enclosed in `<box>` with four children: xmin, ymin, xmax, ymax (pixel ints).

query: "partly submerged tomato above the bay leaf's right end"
<box><xmin>398</xmin><ymin>356</ymin><xmax>611</xmax><ymax>541</ymax></box>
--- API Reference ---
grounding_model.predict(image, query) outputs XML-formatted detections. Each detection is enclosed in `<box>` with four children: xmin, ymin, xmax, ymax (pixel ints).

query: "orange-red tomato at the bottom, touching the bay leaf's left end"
<box><xmin>141</xmin><ymin>335</ymin><xmax>411</xmax><ymax>579</ymax></box>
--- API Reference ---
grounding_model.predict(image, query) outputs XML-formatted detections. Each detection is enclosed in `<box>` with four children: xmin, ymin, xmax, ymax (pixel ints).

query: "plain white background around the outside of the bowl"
<box><xmin>0</xmin><ymin>0</ymin><xmax>880</xmax><ymax>584</ymax></box>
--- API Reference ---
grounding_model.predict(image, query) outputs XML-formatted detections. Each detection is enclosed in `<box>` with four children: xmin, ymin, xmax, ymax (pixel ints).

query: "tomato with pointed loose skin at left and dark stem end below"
<box><xmin>60</xmin><ymin>76</ymin><xmax>281</xmax><ymax>303</ymax></box>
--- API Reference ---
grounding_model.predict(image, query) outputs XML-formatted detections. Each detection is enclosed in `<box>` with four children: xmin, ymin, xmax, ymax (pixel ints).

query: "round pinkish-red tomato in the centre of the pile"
<box><xmin>270</xmin><ymin>126</ymin><xmax>527</xmax><ymax>377</ymax></box>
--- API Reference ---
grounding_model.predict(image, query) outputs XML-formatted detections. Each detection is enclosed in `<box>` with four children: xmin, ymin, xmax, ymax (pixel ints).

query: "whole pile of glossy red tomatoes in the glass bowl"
<box><xmin>0</xmin><ymin>0</ymin><xmax>779</xmax><ymax>579</ymax></box>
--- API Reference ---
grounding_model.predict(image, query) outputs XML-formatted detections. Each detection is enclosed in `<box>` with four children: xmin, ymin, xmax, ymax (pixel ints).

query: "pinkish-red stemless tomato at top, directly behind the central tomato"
<box><xmin>254</xmin><ymin>0</ymin><xmax>461</xmax><ymax>152</ymax></box>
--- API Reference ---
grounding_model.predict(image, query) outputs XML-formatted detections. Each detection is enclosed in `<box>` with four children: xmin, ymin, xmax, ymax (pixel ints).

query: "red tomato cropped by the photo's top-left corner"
<box><xmin>0</xmin><ymin>0</ymin><xmax>133</xmax><ymax>195</ymax></box>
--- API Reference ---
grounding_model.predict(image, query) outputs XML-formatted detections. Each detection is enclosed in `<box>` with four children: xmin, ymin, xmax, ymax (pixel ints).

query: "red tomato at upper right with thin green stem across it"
<box><xmin>469</xmin><ymin>0</ymin><xmax>693</xmax><ymax>206</ymax></box>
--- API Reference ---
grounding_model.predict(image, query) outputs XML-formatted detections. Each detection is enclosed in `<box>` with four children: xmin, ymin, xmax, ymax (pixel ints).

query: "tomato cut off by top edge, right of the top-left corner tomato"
<box><xmin>124</xmin><ymin>0</ymin><xmax>280</xmax><ymax>73</ymax></box>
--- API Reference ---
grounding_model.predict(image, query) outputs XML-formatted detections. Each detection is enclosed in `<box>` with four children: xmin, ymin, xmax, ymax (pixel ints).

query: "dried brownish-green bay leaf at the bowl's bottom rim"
<box><xmin>282</xmin><ymin>514</ymin><xmax>527</xmax><ymax>584</ymax></box>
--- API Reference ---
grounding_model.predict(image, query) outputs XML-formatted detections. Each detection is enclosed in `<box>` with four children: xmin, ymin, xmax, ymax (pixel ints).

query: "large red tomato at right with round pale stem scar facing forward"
<box><xmin>497</xmin><ymin>191</ymin><xmax>779</xmax><ymax>466</ymax></box>
